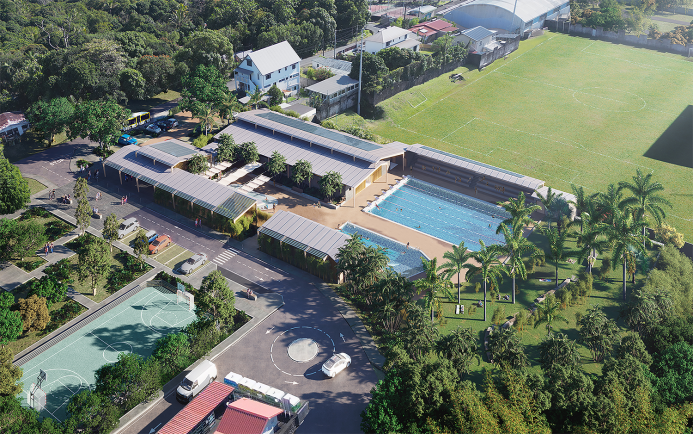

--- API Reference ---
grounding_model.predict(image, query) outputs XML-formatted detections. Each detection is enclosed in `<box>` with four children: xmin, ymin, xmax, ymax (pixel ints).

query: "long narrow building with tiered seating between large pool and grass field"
<box><xmin>404</xmin><ymin>144</ymin><xmax>544</xmax><ymax>200</ymax></box>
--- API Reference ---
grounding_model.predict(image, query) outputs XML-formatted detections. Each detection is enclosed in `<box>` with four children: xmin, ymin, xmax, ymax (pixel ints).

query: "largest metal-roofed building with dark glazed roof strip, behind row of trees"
<box><xmin>214</xmin><ymin>109</ymin><xmax>406</xmax><ymax>200</ymax></box>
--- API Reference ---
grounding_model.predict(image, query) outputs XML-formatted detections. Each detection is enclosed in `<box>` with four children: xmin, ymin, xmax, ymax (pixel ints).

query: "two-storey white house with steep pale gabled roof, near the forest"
<box><xmin>234</xmin><ymin>41</ymin><xmax>301</xmax><ymax>94</ymax></box>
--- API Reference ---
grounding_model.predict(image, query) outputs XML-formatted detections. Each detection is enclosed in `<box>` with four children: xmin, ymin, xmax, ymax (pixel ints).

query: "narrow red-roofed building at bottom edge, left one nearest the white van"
<box><xmin>159</xmin><ymin>382</ymin><xmax>234</xmax><ymax>434</ymax></box>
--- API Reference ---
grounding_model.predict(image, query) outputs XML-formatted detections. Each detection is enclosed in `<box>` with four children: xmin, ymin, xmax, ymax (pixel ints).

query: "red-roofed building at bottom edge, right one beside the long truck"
<box><xmin>214</xmin><ymin>398</ymin><xmax>282</xmax><ymax>434</ymax></box>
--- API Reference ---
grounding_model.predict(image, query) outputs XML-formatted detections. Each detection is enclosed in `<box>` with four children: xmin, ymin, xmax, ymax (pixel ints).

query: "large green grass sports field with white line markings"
<box><xmin>364</xmin><ymin>33</ymin><xmax>693</xmax><ymax>237</ymax></box>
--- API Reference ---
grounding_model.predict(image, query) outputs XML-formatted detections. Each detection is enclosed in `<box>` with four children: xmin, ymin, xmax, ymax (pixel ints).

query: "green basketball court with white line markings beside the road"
<box><xmin>21</xmin><ymin>286</ymin><xmax>195</xmax><ymax>421</ymax></box>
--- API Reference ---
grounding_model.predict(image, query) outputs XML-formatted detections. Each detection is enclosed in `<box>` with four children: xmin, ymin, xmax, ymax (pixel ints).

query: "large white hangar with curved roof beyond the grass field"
<box><xmin>444</xmin><ymin>0</ymin><xmax>570</xmax><ymax>33</ymax></box>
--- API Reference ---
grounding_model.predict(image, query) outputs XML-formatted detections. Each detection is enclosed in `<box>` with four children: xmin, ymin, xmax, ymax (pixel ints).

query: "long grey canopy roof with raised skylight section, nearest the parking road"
<box><xmin>105</xmin><ymin>145</ymin><xmax>255</xmax><ymax>220</ymax></box>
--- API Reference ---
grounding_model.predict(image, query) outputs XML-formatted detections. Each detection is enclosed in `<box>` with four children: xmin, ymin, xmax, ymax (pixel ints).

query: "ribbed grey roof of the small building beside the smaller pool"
<box><xmin>259</xmin><ymin>210</ymin><xmax>349</xmax><ymax>260</ymax></box>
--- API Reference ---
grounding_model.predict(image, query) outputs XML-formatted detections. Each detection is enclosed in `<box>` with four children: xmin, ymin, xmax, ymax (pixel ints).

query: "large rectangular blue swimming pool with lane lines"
<box><xmin>364</xmin><ymin>177</ymin><xmax>510</xmax><ymax>250</ymax></box>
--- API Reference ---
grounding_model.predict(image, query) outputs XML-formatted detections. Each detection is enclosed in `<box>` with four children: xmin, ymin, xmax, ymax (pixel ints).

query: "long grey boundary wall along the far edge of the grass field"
<box><xmin>546</xmin><ymin>20</ymin><xmax>693</xmax><ymax>57</ymax></box>
